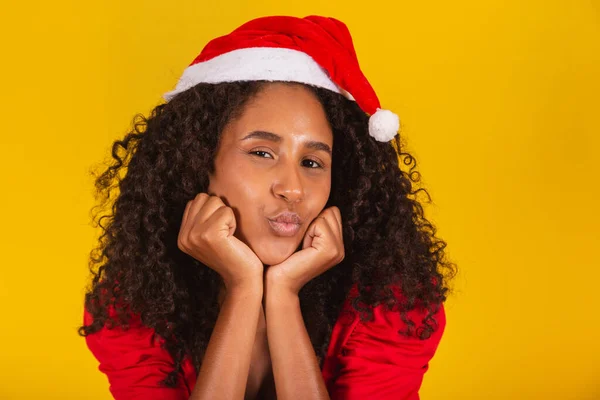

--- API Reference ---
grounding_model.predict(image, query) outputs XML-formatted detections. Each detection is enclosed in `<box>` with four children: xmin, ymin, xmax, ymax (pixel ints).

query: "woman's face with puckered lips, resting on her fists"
<box><xmin>208</xmin><ymin>83</ymin><xmax>333</xmax><ymax>265</ymax></box>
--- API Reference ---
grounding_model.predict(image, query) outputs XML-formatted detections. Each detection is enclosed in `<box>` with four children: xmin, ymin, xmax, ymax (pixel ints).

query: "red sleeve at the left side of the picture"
<box><xmin>84</xmin><ymin>310</ymin><xmax>195</xmax><ymax>400</ymax></box>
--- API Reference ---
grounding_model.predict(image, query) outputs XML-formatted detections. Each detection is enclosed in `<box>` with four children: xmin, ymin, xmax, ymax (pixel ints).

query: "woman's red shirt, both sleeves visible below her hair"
<box><xmin>84</xmin><ymin>286</ymin><xmax>446</xmax><ymax>400</ymax></box>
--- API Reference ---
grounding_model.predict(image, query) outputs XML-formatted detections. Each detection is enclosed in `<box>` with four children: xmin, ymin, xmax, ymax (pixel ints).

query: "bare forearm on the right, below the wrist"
<box><xmin>265</xmin><ymin>282</ymin><xmax>329</xmax><ymax>400</ymax></box>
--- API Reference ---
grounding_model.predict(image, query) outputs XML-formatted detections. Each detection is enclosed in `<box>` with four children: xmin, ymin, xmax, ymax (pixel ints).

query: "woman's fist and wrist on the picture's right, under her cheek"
<box><xmin>265</xmin><ymin>206</ymin><xmax>344</xmax><ymax>294</ymax></box>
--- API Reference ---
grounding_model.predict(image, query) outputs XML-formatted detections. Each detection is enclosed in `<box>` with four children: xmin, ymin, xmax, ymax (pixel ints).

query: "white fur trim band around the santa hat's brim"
<box><xmin>163</xmin><ymin>47</ymin><xmax>354</xmax><ymax>101</ymax></box>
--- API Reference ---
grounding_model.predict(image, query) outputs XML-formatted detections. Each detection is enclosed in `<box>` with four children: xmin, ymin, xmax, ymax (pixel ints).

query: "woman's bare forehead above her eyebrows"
<box><xmin>222</xmin><ymin>83</ymin><xmax>333</xmax><ymax>146</ymax></box>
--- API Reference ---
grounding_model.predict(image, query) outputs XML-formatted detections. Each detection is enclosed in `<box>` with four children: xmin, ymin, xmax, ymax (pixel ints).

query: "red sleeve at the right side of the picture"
<box><xmin>330</xmin><ymin>304</ymin><xmax>446</xmax><ymax>400</ymax></box>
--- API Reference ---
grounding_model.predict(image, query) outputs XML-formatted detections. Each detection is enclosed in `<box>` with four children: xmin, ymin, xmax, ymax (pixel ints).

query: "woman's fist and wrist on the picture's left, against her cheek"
<box><xmin>177</xmin><ymin>193</ymin><xmax>263</xmax><ymax>289</ymax></box>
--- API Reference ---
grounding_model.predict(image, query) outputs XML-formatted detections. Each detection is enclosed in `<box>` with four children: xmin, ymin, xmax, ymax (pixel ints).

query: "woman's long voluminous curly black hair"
<box><xmin>79</xmin><ymin>81</ymin><xmax>456</xmax><ymax>387</ymax></box>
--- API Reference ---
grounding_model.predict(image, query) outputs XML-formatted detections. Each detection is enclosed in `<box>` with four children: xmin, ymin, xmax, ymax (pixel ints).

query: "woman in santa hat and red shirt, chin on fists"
<box><xmin>80</xmin><ymin>16</ymin><xmax>455</xmax><ymax>399</ymax></box>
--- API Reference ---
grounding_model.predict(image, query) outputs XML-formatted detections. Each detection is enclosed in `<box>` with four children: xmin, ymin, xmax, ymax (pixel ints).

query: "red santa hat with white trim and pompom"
<box><xmin>163</xmin><ymin>15</ymin><xmax>400</xmax><ymax>142</ymax></box>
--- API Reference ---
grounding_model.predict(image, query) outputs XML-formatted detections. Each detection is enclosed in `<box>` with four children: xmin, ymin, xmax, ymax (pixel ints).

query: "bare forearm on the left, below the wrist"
<box><xmin>190</xmin><ymin>285</ymin><xmax>263</xmax><ymax>400</ymax></box>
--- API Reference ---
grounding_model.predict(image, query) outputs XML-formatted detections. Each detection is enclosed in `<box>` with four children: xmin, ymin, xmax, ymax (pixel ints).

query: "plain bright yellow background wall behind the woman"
<box><xmin>0</xmin><ymin>0</ymin><xmax>600</xmax><ymax>400</ymax></box>
